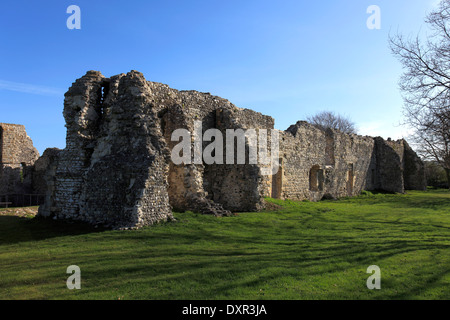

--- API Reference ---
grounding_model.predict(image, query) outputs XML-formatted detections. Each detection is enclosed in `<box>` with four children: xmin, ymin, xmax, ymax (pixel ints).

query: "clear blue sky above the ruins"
<box><xmin>0</xmin><ymin>0</ymin><xmax>437</xmax><ymax>154</ymax></box>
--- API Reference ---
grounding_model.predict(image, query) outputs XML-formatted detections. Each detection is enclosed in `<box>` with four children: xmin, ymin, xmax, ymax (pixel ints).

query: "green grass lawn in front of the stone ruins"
<box><xmin>0</xmin><ymin>190</ymin><xmax>450</xmax><ymax>300</ymax></box>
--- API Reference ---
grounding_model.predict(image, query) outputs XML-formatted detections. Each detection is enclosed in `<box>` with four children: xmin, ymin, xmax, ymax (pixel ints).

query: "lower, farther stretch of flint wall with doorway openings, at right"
<box><xmin>265</xmin><ymin>121</ymin><xmax>426</xmax><ymax>201</ymax></box>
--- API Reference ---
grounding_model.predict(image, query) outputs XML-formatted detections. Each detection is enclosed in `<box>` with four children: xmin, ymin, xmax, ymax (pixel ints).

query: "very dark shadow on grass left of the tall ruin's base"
<box><xmin>0</xmin><ymin>216</ymin><xmax>104</xmax><ymax>245</ymax></box>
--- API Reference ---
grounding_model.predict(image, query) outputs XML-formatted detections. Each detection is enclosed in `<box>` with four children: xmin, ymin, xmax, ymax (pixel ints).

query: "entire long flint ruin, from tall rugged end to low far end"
<box><xmin>0</xmin><ymin>71</ymin><xmax>426</xmax><ymax>228</ymax></box>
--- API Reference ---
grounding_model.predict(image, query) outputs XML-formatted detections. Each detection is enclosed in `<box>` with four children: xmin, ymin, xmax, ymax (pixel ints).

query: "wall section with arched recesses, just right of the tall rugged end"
<box><xmin>153</xmin><ymin>82</ymin><xmax>273</xmax><ymax>215</ymax></box>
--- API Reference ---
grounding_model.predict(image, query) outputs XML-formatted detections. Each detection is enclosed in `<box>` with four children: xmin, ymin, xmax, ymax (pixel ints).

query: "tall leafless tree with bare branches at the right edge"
<box><xmin>389</xmin><ymin>0</ymin><xmax>450</xmax><ymax>189</ymax></box>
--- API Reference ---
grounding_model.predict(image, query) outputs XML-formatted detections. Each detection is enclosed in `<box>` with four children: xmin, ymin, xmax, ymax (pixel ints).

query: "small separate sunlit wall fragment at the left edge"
<box><xmin>0</xmin><ymin>123</ymin><xmax>39</xmax><ymax>195</ymax></box>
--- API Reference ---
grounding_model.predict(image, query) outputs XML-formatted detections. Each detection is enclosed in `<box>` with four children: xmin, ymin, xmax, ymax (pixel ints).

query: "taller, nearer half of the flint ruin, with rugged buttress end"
<box><xmin>40</xmin><ymin>71</ymin><xmax>282</xmax><ymax>226</ymax></box>
